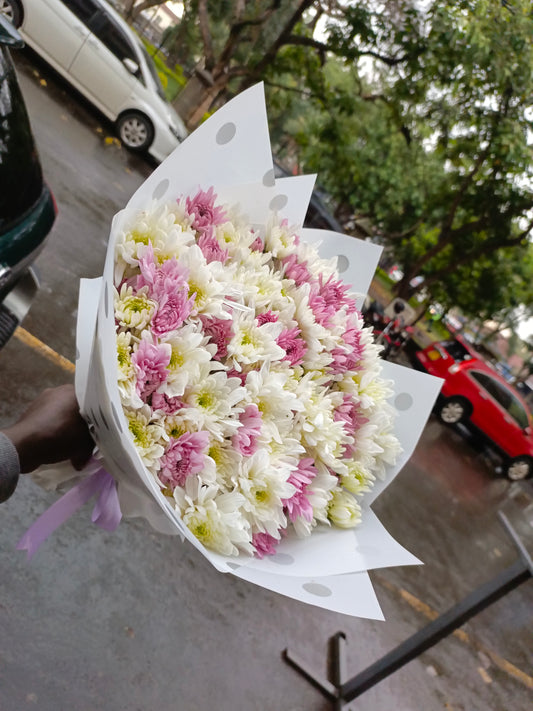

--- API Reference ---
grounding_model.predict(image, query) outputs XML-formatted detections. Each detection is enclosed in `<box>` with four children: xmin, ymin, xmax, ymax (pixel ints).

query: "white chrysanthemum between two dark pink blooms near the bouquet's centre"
<box><xmin>228</xmin><ymin>312</ymin><xmax>285</xmax><ymax>371</ymax></box>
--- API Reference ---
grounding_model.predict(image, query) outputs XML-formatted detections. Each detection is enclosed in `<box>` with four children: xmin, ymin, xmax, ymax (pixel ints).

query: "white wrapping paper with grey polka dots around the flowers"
<box><xmin>52</xmin><ymin>85</ymin><xmax>440</xmax><ymax>619</ymax></box>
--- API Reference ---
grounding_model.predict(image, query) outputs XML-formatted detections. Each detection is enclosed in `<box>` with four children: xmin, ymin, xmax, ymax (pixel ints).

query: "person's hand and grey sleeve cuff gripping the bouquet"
<box><xmin>0</xmin><ymin>385</ymin><xmax>94</xmax><ymax>501</ymax></box>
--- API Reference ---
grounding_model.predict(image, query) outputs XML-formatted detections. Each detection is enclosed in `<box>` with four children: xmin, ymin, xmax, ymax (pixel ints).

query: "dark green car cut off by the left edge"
<box><xmin>0</xmin><ymin>16</ymin><xmax>56</xmax><ymax>348</ymax></box>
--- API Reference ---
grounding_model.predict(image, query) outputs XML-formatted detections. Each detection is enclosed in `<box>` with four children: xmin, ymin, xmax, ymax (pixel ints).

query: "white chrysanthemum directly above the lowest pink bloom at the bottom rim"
<box><xmin>239</xmin><ymin>449</ymin><xmax>296</xmax><ymax>539</ymax></box>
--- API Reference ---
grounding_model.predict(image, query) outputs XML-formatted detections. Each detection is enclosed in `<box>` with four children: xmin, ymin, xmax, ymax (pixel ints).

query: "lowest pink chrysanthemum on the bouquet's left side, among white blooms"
<box><xmin>159</xmin><ymin>431</ymin><xmax>209</xmax><ymax>489</ymax></box>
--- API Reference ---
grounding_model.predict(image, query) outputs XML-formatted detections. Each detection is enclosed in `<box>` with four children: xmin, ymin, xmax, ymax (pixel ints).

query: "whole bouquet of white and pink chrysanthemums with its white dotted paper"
<box><xmin>23</xmin><ymin>85</ymin><xmax>439</xmax><ymax>617</ymax></box>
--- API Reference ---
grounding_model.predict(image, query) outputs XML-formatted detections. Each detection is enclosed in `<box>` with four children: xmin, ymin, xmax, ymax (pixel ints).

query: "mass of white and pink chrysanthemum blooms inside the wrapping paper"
<box><xmin>114</xmin><ymin>187</ymin><xmax>400</xmax><ymax>557</ymax></box>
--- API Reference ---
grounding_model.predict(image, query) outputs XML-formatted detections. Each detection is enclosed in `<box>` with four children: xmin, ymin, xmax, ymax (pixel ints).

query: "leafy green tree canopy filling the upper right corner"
<box><xmin>295</xmin><ymin>0</ymin><xmax>533</xmax><ymax>304</ymax></box>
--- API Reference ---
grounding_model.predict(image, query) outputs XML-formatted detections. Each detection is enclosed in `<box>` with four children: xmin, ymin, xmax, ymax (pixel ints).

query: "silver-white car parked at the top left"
<box><xmin>0</xmin><ymin>0</ymin><xmax>187</xmax><ymax>161</ymax></box>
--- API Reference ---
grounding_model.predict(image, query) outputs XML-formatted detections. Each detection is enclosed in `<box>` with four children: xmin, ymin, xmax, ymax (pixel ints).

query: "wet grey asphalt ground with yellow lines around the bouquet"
<box><xmin>0</xmin><ymin>55</ymin><xmax>533</xmax><ymax>711</ymax></box>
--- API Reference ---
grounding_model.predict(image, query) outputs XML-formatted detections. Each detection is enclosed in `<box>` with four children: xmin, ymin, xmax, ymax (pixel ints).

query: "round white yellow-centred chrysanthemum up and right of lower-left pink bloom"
<box><xmin>180</xmin><ymin>371</ymin><xmax>246</xmax><ymax>440</ymax></box>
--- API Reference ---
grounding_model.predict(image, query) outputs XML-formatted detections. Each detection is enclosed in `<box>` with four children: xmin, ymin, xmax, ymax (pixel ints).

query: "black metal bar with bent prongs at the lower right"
<box><xmin>283</xmin><ymin>511</ymin><xmax>533</xmax><ymax>711</ymax></box>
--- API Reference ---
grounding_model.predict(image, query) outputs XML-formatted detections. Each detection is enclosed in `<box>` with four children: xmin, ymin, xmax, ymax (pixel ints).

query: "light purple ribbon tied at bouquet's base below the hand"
<box><xmin>17</xmin><ymin>468</ymin><xmax>122</xmax><ymax>560</ymax></box>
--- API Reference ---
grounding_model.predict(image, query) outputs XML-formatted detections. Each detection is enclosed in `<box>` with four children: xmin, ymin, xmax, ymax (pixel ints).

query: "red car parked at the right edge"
<box><xmin>414</xmin><ymin>339</ymin><xmax>533</xmax><ymax>481</ymax></box>
